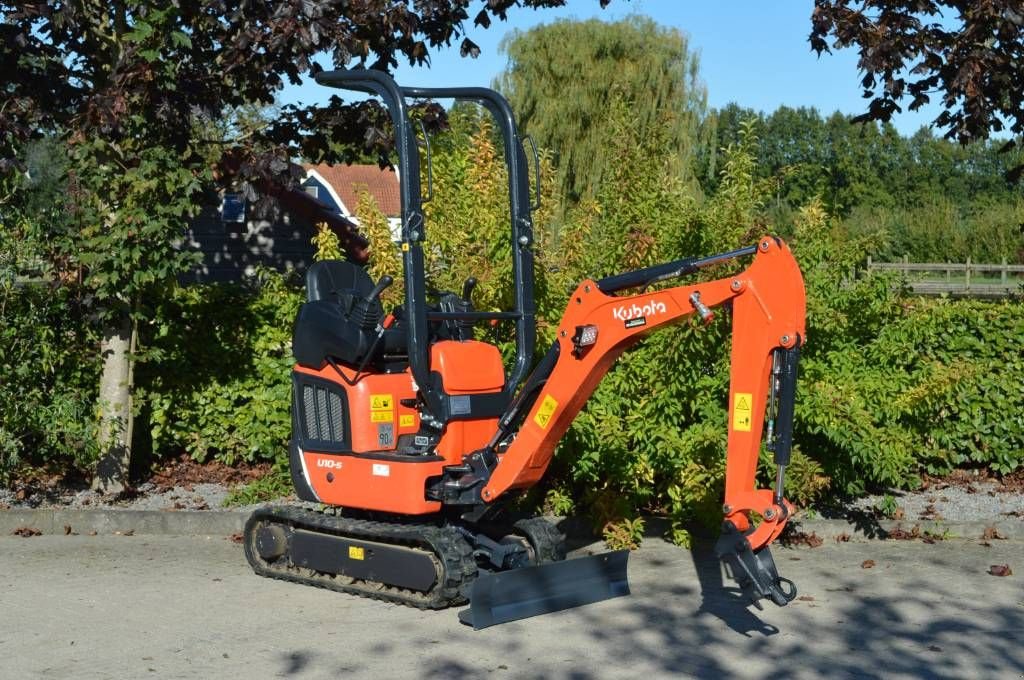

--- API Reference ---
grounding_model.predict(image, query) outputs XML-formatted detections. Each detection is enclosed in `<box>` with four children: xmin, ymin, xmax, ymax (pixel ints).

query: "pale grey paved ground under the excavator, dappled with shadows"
<box><xmin>0</xmin><ymin>535</ymin><xmax>1024</xmax><ymax>680</ymax></box>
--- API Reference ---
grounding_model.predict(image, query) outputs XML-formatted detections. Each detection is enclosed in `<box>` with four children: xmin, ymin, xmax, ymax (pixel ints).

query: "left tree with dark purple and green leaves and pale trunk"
<box><xmin>0</xmin><ymin>0</ymin><xmax>607</xmax><ymax>488</ymax></box>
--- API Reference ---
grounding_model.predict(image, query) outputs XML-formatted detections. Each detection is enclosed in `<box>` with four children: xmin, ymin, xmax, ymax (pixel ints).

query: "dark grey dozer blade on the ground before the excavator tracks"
<box><xmin>459</xmin><ymin>550</ymin><xmax>630</xmax><ymax>630</ymax></box>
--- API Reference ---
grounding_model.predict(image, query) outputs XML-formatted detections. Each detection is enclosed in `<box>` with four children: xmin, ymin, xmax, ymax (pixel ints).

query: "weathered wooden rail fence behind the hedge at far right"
<box><xmin>867</xmin><ymin>256</ymin><xmax>1024</xmax><ymax>298</ymax></box>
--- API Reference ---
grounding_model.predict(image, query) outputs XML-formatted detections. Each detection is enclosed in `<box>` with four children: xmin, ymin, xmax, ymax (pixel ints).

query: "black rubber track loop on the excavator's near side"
<box><xmin>244</xmin><ymin>507</ymin><xmax>476</xmax><ymax>609</ymax></box>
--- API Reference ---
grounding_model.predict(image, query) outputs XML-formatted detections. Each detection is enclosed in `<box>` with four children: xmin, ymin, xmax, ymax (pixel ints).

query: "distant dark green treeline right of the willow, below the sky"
<box><xmin>697</xmin><ymin>103</ymin><xmax>1024</xmax><ymax>220</ymax></box>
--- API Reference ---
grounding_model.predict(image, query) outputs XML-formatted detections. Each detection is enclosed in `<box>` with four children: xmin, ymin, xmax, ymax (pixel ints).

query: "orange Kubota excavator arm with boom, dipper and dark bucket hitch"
<box><xmin>480</xmin><ymin>237</ymin><xmax>805</xmax><ymax>604</ymax></box>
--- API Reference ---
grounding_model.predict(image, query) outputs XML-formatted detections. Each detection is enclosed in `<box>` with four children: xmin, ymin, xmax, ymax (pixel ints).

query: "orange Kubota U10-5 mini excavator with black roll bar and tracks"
<box><xmin>244</xmin><ymin>70</ymin><xmax>805</xmax><ymax>629</ymax></box>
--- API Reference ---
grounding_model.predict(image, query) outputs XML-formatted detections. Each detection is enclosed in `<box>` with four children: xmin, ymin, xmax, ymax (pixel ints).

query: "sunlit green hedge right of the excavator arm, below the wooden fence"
<box><xmin>795</xmin><ymin>197</ymin><xmax>1024</xmax><ymax>494</ymax></box>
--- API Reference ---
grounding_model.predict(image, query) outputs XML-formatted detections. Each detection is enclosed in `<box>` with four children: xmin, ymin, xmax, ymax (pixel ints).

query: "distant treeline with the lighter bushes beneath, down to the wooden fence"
<box><xmin>697</xmin><ymin>104</ymin><xmax>1024</xmax><ymax>262</ymax></box>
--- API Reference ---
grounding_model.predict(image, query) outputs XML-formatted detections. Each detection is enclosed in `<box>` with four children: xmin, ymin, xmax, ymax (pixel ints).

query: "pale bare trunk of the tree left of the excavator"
<box><xmin>92</xmin><ymin>314</ymin><xmax>133</xmax><ymax>494</ymax></box>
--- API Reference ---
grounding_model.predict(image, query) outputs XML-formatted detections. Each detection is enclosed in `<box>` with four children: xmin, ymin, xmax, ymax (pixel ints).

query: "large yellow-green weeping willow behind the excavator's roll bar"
<box><xmin>498</xmin><ymin>16</ymin><xmax>707</xmax><ymax>201</ymax></box>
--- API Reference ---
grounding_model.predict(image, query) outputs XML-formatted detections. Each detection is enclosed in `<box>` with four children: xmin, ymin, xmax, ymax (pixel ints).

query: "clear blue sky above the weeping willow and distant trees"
<box><xmin>281</xmin><ymin>0</ymin><xmax>938</xmax><ymax>134</ymax></box>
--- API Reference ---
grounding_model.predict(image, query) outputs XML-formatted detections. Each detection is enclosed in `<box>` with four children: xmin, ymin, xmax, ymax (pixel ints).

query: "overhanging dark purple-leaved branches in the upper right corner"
<box><xmin>810</xmin><ymin>0</ymin><xmax>1024</xmax><ymax>180</ymax></box>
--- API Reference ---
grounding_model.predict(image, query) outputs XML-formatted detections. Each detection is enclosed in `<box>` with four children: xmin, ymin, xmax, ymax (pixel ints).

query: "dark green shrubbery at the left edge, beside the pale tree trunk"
<box><xmin>0</xmin><ymin>176</ymin><xmax>99</xmax><ymax>481</ymax></box>
